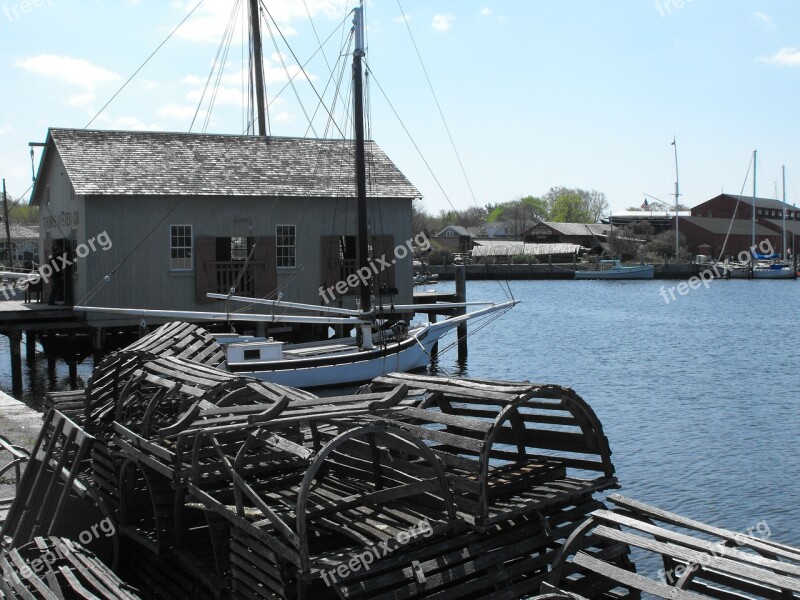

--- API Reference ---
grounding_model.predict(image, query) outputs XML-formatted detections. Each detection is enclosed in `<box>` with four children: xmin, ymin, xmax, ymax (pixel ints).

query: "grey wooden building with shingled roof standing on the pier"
<box><xmin>31</xmin><ymin>129</ymin><xmax>420</xmax><ymax>323</ymax></box>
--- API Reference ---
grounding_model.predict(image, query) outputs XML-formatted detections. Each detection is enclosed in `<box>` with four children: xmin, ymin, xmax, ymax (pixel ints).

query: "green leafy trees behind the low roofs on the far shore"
<box><xmin>413</xmin><ymin>186</ymin><xmax>608</xmax><ymax>238</ymax></box>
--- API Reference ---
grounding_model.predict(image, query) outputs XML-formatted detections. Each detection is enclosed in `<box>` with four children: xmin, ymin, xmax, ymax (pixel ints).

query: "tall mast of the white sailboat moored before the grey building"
<box><xmin>353</xmin><ymin>3</ymin><xmax>372</xmax><ymax>349</ymax></box>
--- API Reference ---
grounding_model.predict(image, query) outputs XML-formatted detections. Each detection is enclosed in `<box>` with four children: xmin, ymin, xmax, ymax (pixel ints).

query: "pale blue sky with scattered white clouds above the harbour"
<box><xmin>0</xmin><ymin>0</ymin><xmax>800</xmax><ymax>214</ymax></box>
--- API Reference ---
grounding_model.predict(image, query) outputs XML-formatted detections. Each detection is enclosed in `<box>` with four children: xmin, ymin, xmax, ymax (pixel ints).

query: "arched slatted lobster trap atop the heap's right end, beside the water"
<box><xmin>363</xmin><ymin>374</ymin><xmax>617</xmax><ymax>530</ymax></box>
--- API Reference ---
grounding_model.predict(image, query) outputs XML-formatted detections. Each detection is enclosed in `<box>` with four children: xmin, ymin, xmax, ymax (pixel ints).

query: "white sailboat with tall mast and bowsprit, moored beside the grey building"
<box><xmin>75</xmin><ymin>6</ymin><xmax>519</xmax><ymax>388</ymax></box>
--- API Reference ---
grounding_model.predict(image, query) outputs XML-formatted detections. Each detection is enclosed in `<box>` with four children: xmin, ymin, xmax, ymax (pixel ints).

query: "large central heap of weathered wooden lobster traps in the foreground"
<box><xmin>1</xmin><ymin>324</ymin><xmax>648</xmax><ymax>599</ymax></box>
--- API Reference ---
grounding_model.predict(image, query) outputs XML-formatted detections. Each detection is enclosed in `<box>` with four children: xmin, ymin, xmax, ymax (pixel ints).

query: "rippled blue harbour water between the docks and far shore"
<box><xmin>0</xmin><ymin>280</ymin><xmax>800</xmax><ymax>546</ymax></box>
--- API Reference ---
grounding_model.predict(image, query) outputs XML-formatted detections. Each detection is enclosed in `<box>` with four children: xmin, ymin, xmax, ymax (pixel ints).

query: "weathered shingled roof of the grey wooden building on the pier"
<box><xmin>33</xmin><ymin>129</ymin><xmax>420</xmax><ymax>200</ymax></box>
